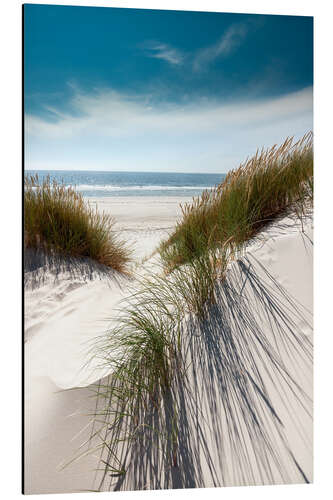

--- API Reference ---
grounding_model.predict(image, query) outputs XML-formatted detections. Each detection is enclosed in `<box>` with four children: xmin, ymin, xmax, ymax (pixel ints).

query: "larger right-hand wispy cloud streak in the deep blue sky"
<box><xmin>193</xmin><ymin>24</ymin><xmax>248</xmax><ymax>71</ymax></box>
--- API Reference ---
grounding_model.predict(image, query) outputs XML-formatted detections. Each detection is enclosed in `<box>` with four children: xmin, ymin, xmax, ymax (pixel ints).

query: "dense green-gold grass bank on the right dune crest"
<box><xmin>159</xmin><ymin>133</ymin><xmax>313</xmax><ymax>271</ymax></box>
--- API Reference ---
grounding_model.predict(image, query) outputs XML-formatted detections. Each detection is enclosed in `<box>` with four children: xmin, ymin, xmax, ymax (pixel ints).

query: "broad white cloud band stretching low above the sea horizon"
<box><xmin>26</xmin><ymin>88</ymin><xmax>312</xmax><ymax>172</ymax></box>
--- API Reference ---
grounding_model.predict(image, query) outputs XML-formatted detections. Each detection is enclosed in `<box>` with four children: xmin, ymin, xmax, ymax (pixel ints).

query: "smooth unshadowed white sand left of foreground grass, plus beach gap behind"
<box><xmin>24</xmin><ymin>197</ymin><xmax>189</xmax><ymax>493</ymax></box>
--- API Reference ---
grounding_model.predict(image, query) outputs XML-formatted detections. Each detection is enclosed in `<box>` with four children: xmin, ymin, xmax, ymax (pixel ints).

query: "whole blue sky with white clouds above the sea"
<box><xmin>24</xmin><ymin>4</ymin><xmax>313</xmax><ymax>172</ymax></box>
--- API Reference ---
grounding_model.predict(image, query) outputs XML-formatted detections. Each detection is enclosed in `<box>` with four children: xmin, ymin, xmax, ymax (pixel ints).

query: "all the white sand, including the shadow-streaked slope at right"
<box><xmin>24</xmin><ymin>197</ymin><xmax>313</xmax><ymax>494</ymax></box>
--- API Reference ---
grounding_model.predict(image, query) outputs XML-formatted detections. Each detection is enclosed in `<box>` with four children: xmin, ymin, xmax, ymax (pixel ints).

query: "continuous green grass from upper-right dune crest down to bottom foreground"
<box><xmin>72</xmin><ymin>134</ymin><xmax>313</xmax><ymax>489</ymax></box>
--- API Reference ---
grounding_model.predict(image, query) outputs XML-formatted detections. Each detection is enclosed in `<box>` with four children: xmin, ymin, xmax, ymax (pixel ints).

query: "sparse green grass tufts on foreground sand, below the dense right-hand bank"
<box><xmin>80</xmin><ymin>252</ymin><xmax>225</xmax><ymax>490</ymax></box>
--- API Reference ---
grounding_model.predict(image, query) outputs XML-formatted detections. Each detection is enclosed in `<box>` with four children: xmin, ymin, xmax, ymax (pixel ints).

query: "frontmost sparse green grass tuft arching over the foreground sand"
<box><xmin>80</xmin><ymin>274</ymin><xmax>184</xmax><ymax>490</ymax></box>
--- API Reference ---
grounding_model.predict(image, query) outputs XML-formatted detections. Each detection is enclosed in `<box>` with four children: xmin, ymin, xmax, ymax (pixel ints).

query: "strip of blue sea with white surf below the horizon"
<box><xmin>25</xmin><ymin>170</ymin><xmax>225</xmax><ymax>197</ymax></box>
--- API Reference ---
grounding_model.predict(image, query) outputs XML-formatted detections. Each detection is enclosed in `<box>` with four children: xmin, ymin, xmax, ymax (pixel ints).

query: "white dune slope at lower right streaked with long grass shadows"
<box><xmin>85</xmin><ymin>257</ymin><xmax>312</xmax><ymax>490</ymax></box>
